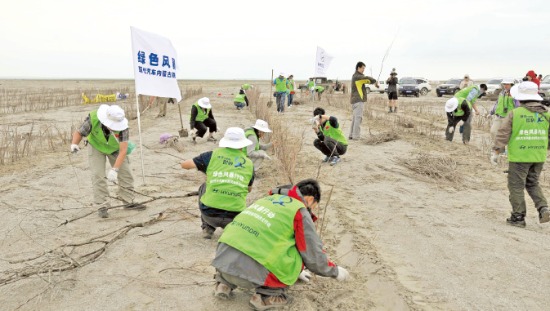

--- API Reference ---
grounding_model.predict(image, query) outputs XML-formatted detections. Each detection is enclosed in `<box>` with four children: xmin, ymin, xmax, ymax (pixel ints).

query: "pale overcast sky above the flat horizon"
<box><xmin>0</xmin><ymin>0</ymin><xmax>550</xmax><ymax>80</ymax></box>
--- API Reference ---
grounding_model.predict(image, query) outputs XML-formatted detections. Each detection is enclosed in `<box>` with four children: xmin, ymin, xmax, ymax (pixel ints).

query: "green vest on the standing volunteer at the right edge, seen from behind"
<box><xmin>508</xmin><ymin>107</ymin><xmax>550</xmax><ymax>163</ymax></box>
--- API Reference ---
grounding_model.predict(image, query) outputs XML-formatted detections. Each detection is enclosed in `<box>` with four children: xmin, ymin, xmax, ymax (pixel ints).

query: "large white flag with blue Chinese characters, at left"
<box><xmin>130</xmin><ymin>27</ymin><xmax>181</xmax><ymax>102</ymax></box>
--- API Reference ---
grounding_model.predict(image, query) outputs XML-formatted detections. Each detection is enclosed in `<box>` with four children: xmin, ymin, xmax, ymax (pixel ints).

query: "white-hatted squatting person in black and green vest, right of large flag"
<box><xmin>189</xmin><ymin>97</ymin><xmax>218</xmax><ymax>142</ymax></box>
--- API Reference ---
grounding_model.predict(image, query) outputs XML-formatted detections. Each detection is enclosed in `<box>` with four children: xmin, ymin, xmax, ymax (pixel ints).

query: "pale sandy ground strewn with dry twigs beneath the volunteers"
<box><xmin>0</xmin><ymin>81</ymin><xmax>550</xmax><ymax>310</ymax></box>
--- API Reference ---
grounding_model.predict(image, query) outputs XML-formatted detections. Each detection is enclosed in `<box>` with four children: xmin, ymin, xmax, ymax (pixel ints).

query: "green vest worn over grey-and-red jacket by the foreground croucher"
<box><xmin>218</xmin><ymin>194</ymin><xmax>305</xmax><ymax>285</ymax></box>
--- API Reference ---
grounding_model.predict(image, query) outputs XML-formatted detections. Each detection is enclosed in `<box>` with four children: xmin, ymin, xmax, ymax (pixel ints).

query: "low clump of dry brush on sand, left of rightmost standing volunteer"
<box><xmin>398</xmin><ymin>153</ymin><xmax>462</xmax><ymax>183</ymax></box>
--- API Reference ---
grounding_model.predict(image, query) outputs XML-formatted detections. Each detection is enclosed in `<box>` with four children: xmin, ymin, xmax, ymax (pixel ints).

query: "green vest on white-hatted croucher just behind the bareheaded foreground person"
<box><xmin>201</xmin><ymin>148</ymin><xmax>254</xmax><ymax>212</ymax></box>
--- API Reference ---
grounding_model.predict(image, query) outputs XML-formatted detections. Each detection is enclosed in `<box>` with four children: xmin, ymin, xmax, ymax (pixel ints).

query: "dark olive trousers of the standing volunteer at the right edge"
<box><xmin>508</xmin><ymin>162</ymin><xmax>548</xmax><ymax>216</ymax></box>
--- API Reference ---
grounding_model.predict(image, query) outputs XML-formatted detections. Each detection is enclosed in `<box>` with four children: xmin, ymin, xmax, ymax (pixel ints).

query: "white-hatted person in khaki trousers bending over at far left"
<box><xmin>71</xmin><ymin>105</ymin><xmax>145</xmax><ymax>218</ymax></box>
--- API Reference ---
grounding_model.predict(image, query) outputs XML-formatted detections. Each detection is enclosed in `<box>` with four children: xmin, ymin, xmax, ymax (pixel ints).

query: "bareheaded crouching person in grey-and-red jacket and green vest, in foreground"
<box><xmin>212</xmin><ymin>179</ymin><xmax>349</xmax><ymax>310</ymax></box>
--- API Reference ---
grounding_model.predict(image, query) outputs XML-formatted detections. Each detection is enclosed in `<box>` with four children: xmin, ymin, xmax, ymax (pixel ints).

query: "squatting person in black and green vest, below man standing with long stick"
<box><xmin>311</xmin><ymin>107</ymin><xmax>348</xmax><ymax>165</ymax></box>
